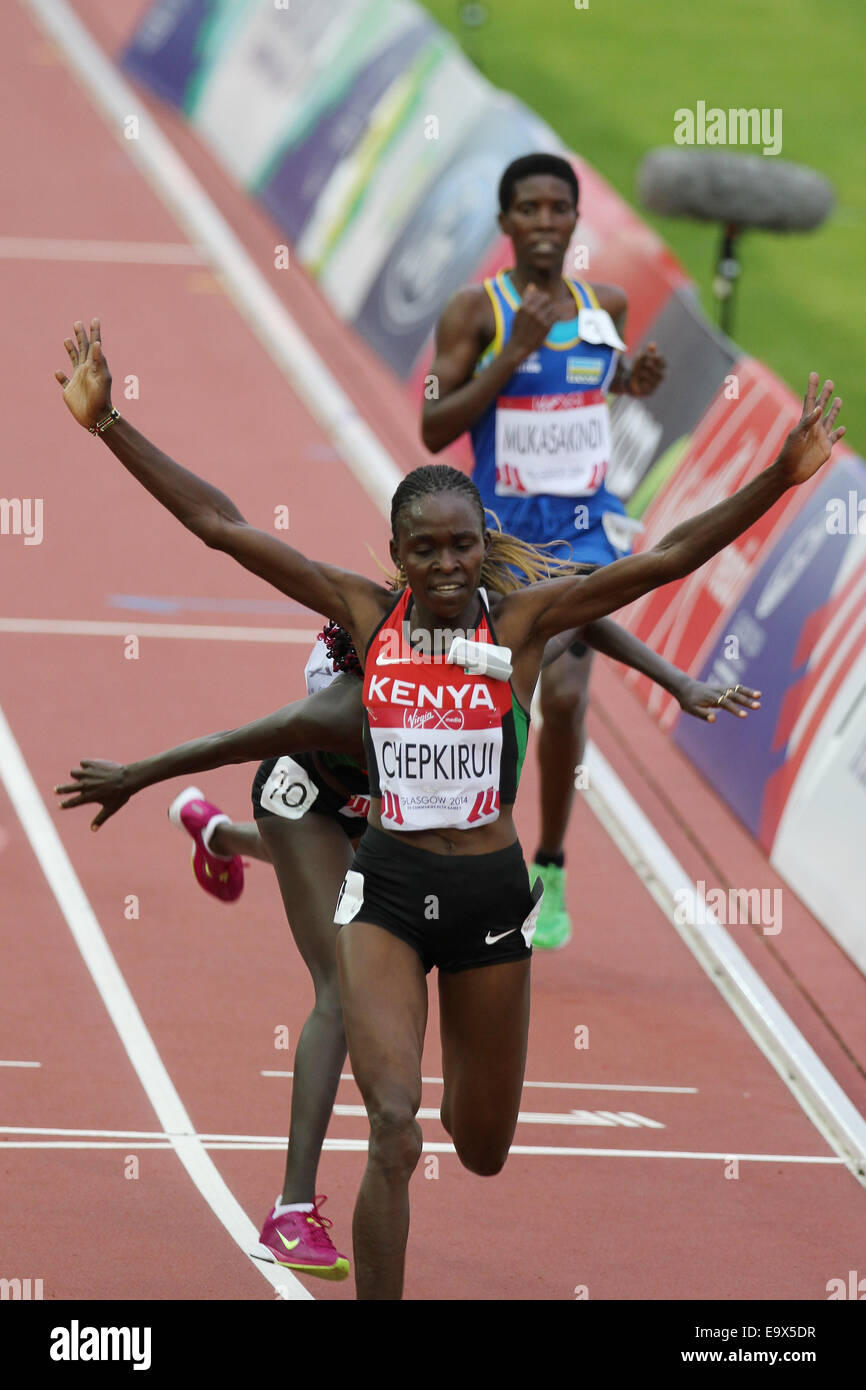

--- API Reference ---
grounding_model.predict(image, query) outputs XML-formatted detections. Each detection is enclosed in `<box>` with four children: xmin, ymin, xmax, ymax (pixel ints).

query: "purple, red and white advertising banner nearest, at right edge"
<box><xmin>674</xmin><ymin>455</ymin><xmax>866</xmax><ymax>970</ymax></box>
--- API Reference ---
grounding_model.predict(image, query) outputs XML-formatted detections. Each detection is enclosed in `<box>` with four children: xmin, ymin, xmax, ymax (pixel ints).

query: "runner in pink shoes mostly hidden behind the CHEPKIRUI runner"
<box><xmin>54</xmin><ymin>608</ymin><xmax>760</xmax><ymax>1279</ymax></box>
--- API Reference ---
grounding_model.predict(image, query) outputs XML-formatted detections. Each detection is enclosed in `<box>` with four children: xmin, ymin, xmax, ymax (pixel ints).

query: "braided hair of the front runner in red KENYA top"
<box><xmin>391</xmin><ymin>463</ymin><xmax>595</xmax><ymax>594</ymax></box>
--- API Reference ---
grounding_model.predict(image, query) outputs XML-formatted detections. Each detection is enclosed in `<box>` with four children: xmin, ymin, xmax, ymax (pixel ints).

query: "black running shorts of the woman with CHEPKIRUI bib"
<box><xmin>334</xmin><ymin>827</ymin><xmax>542</xmax><ymax>972</ymax></box>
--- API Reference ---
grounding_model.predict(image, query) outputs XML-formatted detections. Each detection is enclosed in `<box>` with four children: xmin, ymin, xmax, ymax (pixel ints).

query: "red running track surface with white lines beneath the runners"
<box><xmin>0</xmin><ymin>0</ymin><xmax>866</xmax><ymax>1301</ymax></box>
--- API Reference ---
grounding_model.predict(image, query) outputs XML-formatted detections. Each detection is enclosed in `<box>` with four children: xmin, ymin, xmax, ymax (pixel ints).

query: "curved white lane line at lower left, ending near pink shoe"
<box><xmin>0</xmin><ymin>709</ymin><xmax>313</xmax><ymax>1298</ymax></box>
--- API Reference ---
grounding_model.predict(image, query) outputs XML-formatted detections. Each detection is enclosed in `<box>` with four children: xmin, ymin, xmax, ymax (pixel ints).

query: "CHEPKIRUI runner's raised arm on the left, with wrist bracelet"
<box><xmin>54</xmin><ymin>318</ymin><xmax>388</xmax><ymax>637</ymax></box>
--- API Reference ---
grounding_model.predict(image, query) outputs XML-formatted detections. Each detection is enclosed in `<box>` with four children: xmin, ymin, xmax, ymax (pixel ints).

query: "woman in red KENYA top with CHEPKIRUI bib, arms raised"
<box><xmin>56</xmin><ymin>320</ymin><xmax>844</xmax><ymax>1298</ymax></box>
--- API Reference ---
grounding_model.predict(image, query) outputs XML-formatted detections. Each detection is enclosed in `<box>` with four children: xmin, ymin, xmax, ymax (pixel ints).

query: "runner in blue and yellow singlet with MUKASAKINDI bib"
<box><xmin>421</xmin><ymin>154</ymin><xmax>664</xmax><ymax>947</ymax></box>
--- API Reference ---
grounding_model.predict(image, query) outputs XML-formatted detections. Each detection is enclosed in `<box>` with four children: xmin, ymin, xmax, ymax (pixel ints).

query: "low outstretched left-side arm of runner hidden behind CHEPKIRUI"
<box><xmin>54</xmin><ymin>676</ymin><xmax>363</xmax><ymax>830</ymax></box>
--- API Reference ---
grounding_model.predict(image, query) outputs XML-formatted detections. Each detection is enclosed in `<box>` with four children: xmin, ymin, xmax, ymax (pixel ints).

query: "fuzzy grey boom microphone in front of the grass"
<box><xmin>638</xmin><ymin>149</ymin><xmax>834</xmax><ymax>232</ymax></box>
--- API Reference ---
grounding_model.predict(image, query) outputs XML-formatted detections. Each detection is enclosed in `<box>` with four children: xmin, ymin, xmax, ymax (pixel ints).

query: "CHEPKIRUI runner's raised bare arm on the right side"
<box><xmin>508</xmin><ymin>373</ymin><xmax>845</xmax><ymax>641</ymax></box>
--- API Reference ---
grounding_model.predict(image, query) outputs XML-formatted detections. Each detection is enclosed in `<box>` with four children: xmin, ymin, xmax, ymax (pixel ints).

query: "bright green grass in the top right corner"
<box><xmin>425</xmin><ymin>0</ymin><xmax>866</xmax><ymax>455</ymax></box>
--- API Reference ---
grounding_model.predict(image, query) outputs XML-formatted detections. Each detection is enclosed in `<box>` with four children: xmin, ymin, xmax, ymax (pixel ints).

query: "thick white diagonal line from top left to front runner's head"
<box><xmin>26</xmin><ymin>0</ymin><xmax>403</xmax><ymax>512</ymax></box>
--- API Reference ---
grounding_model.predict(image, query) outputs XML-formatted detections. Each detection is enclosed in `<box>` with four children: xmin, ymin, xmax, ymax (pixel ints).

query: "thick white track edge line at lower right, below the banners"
<box><xmin>584</xmin><ymin>742</ymin><xmax>866</xmax><ymax>1187</ymax></box>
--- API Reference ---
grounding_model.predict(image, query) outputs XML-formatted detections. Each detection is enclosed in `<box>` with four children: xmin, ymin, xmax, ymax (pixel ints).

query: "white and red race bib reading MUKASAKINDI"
<box><xmin>496</xmin><ymin>391</ymin><xmax>610</xmax><ymax>498</ymax></box>
